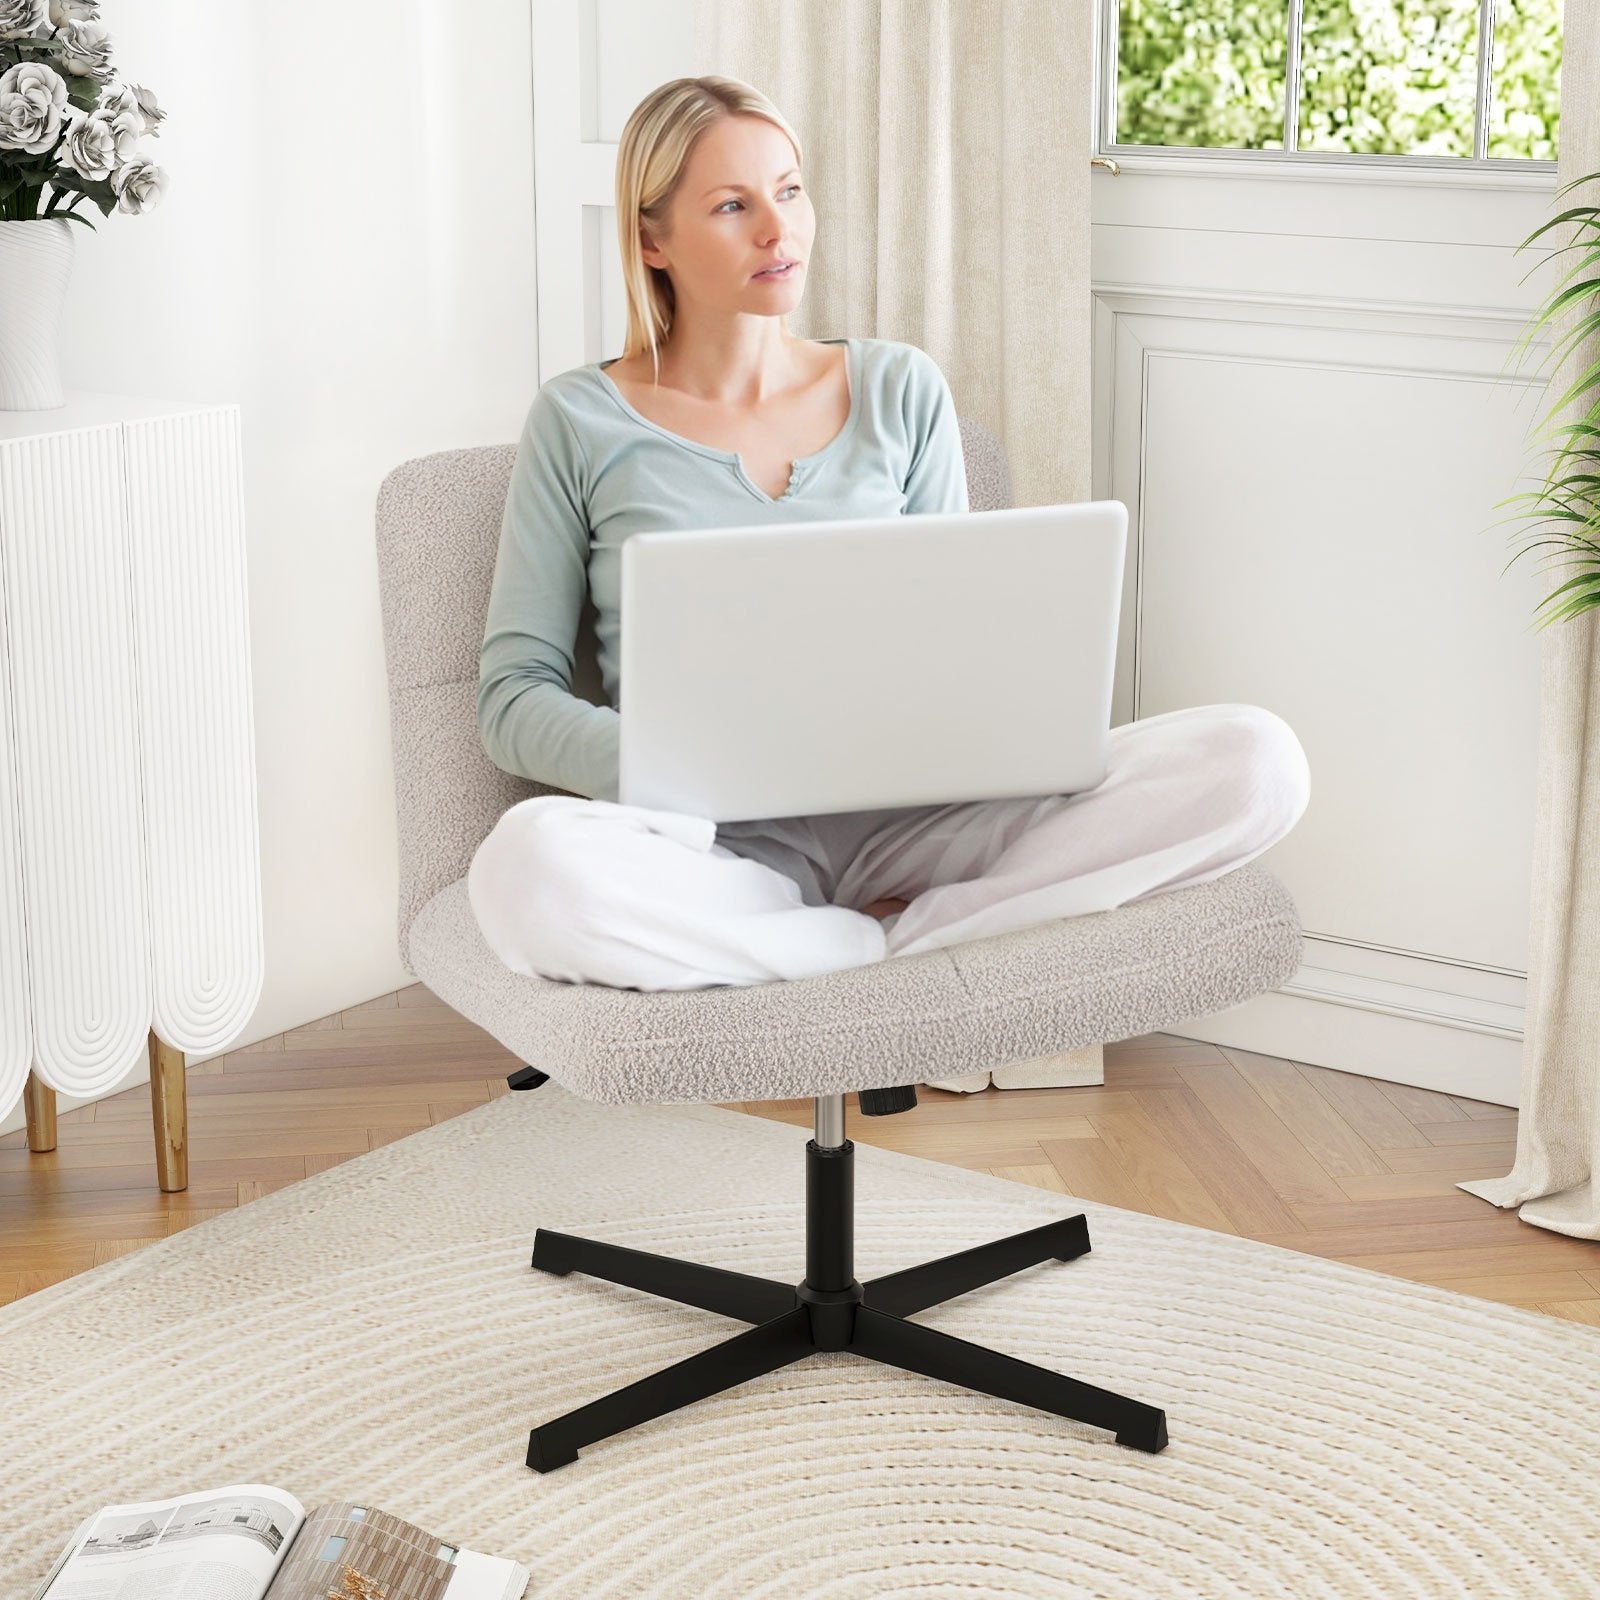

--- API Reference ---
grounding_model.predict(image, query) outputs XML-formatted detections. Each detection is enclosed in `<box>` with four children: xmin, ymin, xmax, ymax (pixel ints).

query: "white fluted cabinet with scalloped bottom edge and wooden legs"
<box><xmin>0</xmin><ymin>392</ymin><xmax>262</xmax><ymax>1190</ymax></box>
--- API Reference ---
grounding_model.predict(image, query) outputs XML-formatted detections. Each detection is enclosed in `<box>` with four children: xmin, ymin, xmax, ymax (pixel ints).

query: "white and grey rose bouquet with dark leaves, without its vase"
<box><xmin>0</xmin><ymin>0</ymin><xmax>166</xmax><ymax>229</ymax></box>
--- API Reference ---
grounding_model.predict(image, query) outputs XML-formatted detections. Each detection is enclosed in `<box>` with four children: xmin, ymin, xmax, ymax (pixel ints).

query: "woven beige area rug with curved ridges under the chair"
<box><xmin>0</xmin><ymin>1083</ymin><xmax>1600</xmax><ymax>1600</ymax></box>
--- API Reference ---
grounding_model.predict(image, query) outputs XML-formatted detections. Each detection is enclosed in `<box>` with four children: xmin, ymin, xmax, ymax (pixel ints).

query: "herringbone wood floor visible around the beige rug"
<box><xmin>0</xmin><ymin>984</ymin><xmax>1600</xmax><ymax>1325</ymax></box>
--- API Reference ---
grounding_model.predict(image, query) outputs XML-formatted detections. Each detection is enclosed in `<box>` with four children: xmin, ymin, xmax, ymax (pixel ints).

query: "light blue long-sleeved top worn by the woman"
<box><xmin>478</xmin><ymin>339</ymin><xmax>968</xmax><ymax>800</ymax></box>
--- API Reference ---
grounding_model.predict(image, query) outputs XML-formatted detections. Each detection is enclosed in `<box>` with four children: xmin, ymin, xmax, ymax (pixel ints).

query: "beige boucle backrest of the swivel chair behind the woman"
<box><xmin>378</xmin><ymin>418</ymin><xmax>1011</xmax><ymax>970</ymax></box>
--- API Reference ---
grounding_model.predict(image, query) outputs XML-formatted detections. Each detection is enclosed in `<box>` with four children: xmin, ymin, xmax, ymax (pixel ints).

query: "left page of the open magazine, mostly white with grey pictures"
<box><xmin>40</xmin><ymin>1483</ymin><xmax>306</xmax><ymax>1600</ymax></box>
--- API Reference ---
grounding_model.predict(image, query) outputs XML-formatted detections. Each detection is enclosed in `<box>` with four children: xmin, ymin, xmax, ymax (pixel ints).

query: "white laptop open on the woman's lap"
<box><xmin>618</xmin><ymin>501</ymin><xmax>1128</xmax><ymax>822</ymax></box>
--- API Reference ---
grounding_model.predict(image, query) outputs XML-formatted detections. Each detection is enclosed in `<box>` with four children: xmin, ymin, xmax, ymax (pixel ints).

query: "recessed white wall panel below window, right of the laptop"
<box><xmin>1138</xmin><ymin>338</ymin><xmax>1538</xmax><ymax>970</ymax></box>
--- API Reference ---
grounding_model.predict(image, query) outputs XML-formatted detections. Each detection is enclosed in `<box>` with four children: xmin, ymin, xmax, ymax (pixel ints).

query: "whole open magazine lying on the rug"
<box><xmin>34</xmin><ymin>1483</ymin><xmax>528</xmax><ymax>1600</ymax></box>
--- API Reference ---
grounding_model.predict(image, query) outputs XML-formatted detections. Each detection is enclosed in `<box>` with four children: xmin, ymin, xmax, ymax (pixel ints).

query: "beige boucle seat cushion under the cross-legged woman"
<box><xmin>408</xmin><ymin>862</ymin><xmax>1301</xmax><ymax>1104</ymax></box>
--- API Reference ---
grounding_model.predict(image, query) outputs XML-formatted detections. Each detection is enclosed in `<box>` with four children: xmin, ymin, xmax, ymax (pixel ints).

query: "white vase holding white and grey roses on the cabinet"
<box><xmin>0</xmin><ymin>0</ymin><xmax>166</xmax><ymax>411</ymax></box>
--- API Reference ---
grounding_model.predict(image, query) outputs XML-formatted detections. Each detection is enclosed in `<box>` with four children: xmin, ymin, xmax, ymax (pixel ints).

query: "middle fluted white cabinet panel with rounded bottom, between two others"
<box><xmin>0</xmin><ymin>424</ymin><xmax>150</xmax><ymax>1096</ymax></box>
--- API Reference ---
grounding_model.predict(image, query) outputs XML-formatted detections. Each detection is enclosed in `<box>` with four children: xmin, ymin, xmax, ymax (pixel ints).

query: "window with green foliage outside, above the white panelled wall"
<box><xmin>1101</xmin><ymin>0</ymin><xmax>1562</xmax><ymax>165</ymax></box>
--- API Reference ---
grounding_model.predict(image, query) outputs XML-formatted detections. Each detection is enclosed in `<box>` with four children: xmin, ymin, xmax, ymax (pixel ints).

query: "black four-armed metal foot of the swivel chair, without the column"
<box><xmin>528</xmin><ymin>1214</ymin><xmax>1166</xmax><ymax>1472</ymax></box>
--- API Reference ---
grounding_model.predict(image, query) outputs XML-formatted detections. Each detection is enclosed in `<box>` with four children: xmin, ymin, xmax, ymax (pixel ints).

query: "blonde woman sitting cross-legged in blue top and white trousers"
<box><xmin>467</xmin><ymin>77</ymin><xmax>1309</xmax><ymax>1024</ymax></box>
